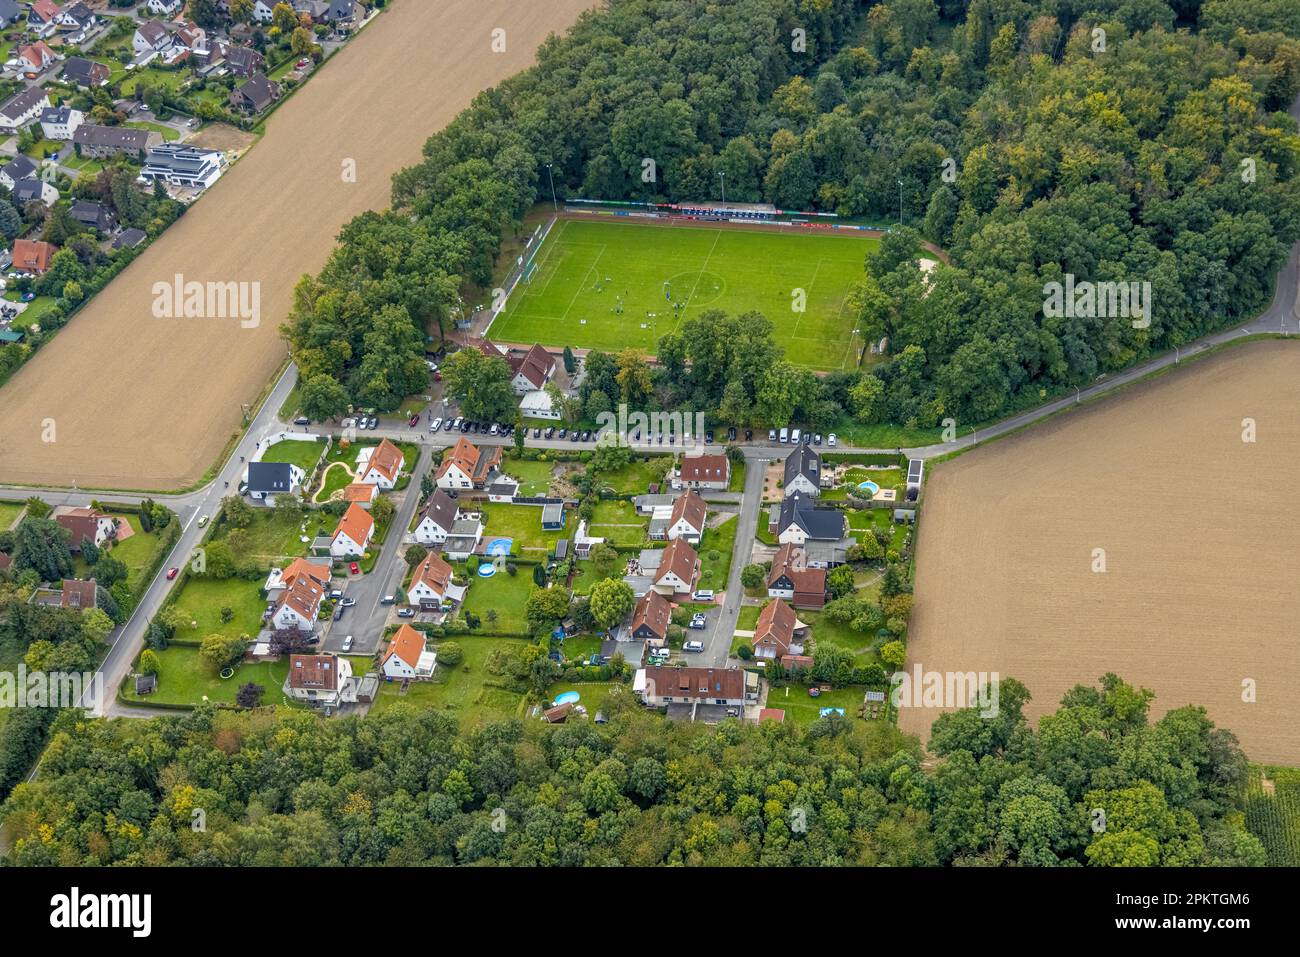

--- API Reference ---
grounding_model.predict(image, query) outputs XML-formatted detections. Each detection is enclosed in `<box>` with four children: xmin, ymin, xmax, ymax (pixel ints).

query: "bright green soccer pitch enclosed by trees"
<box><xmin>489</xmin><ymin>220</ymin><xmax>878</xmax><ymax>371</ymax></box>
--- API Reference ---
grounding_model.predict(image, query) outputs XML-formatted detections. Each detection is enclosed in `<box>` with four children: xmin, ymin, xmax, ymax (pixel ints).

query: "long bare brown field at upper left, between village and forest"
<box><xmin>0</xmin><ymin>0</ymin><xmax>592</xmax><ymax>490</ymax></box>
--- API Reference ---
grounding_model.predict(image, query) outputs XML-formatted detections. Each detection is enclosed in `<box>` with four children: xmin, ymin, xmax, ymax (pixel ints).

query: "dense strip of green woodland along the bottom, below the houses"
<box><xmin>0</xmin><ymin>675</ymin><xmax>1265</xmax><ymax>866</ymax></box>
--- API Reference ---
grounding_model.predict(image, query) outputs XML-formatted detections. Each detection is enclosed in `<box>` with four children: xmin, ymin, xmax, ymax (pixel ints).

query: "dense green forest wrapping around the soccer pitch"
<box><xmin>283</xmin><ymin>0</ymin><xmax>1300</xmax><ymax>426</ymax></box>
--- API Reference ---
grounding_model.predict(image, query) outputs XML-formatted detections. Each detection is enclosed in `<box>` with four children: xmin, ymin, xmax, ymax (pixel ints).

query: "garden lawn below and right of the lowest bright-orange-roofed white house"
<box><xmin>373</xmin><ymin>636</ymin><xmax>528</xmax><ymax>727</ymax></box>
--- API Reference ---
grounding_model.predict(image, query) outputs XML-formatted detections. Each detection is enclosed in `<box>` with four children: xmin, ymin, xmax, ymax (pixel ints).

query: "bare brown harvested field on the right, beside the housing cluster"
<box><xmin>900</xmin><ymin>342</ymin><xmax>1300</xmax><ymax>765</ymax></box>
